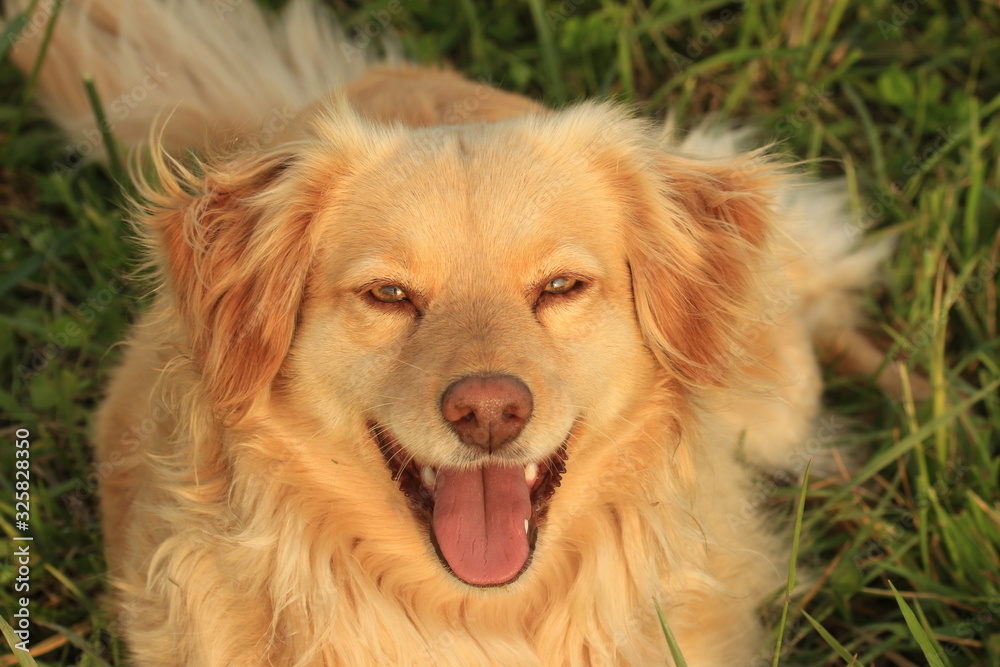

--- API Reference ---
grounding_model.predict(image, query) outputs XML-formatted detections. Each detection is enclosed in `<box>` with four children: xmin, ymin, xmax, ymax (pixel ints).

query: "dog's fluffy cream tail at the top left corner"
<box><xmin>5</xmin><ymin>0</ymin><xmax>367</xmax><ymax>157</ymax></box>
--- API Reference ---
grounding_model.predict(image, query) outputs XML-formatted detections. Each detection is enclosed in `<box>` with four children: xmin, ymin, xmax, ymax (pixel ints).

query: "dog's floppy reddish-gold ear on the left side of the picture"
<box><xmin>139</xmin><ymin>152</ymin><xmax>319</xmax><ymax>416</ymax></box>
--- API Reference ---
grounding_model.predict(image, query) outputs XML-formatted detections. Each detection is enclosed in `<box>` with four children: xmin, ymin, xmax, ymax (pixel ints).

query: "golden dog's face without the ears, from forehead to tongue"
<box><xmin>290</xmin><ymin>128</ymin><xmax>652</xmax><ymax>586</ymax></box>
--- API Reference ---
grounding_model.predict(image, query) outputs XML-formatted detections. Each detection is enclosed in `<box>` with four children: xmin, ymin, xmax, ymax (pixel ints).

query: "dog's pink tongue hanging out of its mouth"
<box><xmin>434</xmin><ymin>465</ymin><xmax>531</xmax><ymax>586</ymax></box>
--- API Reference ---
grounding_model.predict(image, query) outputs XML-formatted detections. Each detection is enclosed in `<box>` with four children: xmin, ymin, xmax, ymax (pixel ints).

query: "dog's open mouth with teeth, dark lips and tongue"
<box><xmin>369</xmin><ymin>423</ymin><xmax>568</xmax><ymax>587</ymax></box>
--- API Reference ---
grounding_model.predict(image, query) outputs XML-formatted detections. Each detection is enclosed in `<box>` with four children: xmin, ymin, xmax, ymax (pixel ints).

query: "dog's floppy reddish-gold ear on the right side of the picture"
<box><xmin>626</xmin><ymin>153</ymin><xmax>779</xmax><ymax>386</ymax></box>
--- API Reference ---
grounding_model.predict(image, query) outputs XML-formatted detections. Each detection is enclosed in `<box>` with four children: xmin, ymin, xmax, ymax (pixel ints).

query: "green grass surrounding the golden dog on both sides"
<box><xmin>0</xmin><ymin>0</ymin><xmax>1000</xmax><ymax>667</ymax></box>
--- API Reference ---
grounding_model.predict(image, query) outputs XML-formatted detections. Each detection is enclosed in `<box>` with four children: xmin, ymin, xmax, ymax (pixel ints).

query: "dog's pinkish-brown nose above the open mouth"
<box><xmin>441</xmin><ymin>375</ymin><xmax>532</xmax><ymax>452</ymax></box>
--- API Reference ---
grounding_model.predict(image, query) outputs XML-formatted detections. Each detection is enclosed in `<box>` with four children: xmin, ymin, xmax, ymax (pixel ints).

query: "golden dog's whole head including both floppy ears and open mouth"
<box><xmin>146</xmin><ymin>105</ymin><xmax>773</xmax><ymax>586</ymax></box>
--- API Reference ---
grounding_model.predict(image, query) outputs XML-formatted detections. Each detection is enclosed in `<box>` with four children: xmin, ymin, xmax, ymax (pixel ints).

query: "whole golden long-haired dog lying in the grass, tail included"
<box><xmin>9</xmin><ymin>0</ymin><xmax>893</xmax><ymax>666</ymax></box>
